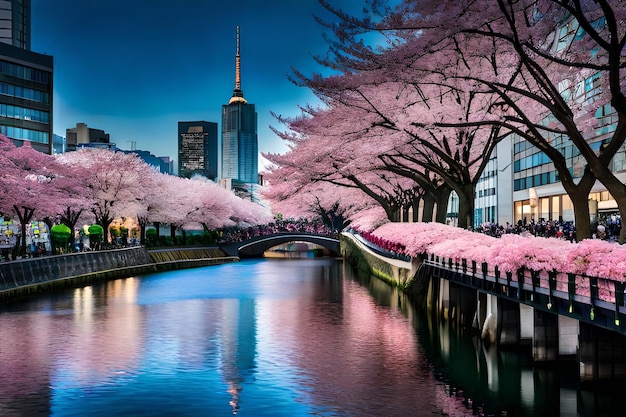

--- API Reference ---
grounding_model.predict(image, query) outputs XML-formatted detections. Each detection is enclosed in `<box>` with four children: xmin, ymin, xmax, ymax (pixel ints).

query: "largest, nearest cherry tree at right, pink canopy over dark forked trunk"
<box><xmin>322</xmin><ymin>0</ymin><xmax>626</xmax><ymax>241</ymax></box>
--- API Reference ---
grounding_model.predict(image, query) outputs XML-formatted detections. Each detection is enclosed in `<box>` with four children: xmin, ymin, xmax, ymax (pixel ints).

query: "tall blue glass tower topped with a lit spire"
<box><xmin>222</xmin><ymin>26</ymin><xmax>259</xmax><ymax>190</ymax></box>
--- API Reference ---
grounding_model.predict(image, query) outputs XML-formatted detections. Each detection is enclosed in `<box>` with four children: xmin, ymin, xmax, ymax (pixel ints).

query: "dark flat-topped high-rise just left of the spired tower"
<box><xmin>178</xmin><ymin>121</ymin><xmax>218</xmax><ymax>180</ymax></box>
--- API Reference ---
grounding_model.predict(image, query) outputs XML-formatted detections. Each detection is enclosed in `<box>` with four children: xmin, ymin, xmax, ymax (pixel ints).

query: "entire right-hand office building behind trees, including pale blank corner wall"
<box><xmin>475</xmin><ymin>15</ymin><xmax>626</xmax><ymax>231</ymax></box>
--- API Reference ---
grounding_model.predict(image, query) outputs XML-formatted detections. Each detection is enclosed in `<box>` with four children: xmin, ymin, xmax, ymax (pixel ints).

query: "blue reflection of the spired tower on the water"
<box><xmin>222</xmin><ymin>299</ymin><xmax>257</xmax><ymax>414</ymax></box>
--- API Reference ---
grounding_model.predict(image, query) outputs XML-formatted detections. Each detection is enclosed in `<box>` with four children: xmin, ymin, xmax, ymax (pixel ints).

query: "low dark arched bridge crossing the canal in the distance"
<box><xmin>220</xmin><ymin>233</ymin><xmax>340</xmax><ymax>258</ymax></box>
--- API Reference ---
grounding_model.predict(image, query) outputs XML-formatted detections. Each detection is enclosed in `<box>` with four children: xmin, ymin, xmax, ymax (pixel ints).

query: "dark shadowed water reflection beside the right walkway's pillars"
<box><xmin>346</xmin><ymin>262</ymin><xmax>623</xmax><ymax>416</ymax></box>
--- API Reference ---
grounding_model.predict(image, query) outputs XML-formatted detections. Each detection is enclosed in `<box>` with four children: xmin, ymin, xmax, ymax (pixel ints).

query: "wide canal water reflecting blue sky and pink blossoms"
<box><xmin>0</xmin><ymin>259</ymin><xmax>622</xmax><ymax>417</ymax></box>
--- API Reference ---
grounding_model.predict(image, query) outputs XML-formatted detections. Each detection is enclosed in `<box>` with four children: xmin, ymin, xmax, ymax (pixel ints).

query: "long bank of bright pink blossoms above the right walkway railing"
<box><xmin>364</xmin><ymin>222</ymin><xmax>626</xmax><ymax>282</ymax></box>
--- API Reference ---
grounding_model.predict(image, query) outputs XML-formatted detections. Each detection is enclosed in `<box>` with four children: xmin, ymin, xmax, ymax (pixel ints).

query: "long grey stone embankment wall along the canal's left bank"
<box><xmin>0</xmin><ymin>246</ymin><xmax>239</xmax><ymax>301</ymax></box>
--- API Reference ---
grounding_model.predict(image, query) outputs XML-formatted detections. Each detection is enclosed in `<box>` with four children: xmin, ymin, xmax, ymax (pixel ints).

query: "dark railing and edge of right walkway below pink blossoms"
<box><xmin>420</xmin><ymin>255</ymin><xmax>626</xmax><ymax>334</ymax></box>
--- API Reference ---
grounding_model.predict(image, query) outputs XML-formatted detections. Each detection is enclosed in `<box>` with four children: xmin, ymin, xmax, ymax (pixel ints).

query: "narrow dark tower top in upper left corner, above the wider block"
<box><xmin>0</xmin><ymin>0</ymin><xmax>30</xmax><ymax>51</ymax></box>
